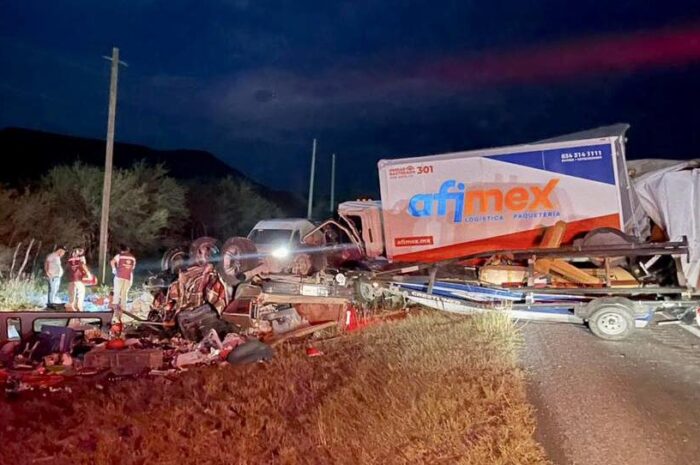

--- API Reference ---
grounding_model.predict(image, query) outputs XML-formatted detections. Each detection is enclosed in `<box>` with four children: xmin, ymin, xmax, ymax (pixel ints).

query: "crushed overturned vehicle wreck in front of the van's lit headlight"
<box><xmin>142</xmin><ymin>263</ymin><xmax>396</xmax><ymax>340</ymax></box>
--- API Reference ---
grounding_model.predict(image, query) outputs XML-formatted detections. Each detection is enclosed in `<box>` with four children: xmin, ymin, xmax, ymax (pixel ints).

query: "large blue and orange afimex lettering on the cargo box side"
<box><xmin>408</xmin><ymin>178</ymin><xmax>559</xmax><ymax>223</ymax></box>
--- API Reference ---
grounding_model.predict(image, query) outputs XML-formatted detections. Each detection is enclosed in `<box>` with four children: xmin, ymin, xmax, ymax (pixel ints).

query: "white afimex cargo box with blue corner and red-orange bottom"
<box><xmin>379</xmin><ymin>130</ymin><xmax>639</xmax><ymax>261</ymax></box>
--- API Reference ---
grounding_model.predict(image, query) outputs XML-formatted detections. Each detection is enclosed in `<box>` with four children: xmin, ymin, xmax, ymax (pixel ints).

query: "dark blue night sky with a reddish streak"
<box><xmin>0</xmin><ymin>0</ymin><xmax>700</xmax><ymax>195</ymax></box>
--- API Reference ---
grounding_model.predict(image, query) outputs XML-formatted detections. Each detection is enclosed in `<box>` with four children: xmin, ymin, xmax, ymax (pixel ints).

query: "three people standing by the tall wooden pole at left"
<box><xmin>44</xmin><ymin>245</ymin><xmax>136</xmax><ymax>314</ymax></box>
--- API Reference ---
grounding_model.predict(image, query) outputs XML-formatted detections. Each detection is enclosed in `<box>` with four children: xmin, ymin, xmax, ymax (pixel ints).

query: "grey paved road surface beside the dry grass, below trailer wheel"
<box><xmin>522</xmin><ymin>323</ymin><xmax>700</xmax><ymax>465</ymax></box>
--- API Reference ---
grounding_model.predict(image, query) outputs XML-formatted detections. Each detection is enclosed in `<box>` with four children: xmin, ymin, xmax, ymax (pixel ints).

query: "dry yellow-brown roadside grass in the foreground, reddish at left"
<box><xmin>0</xmin><ymin>313</ymin><xmax>546</xmax><ymax>465</ymax></box>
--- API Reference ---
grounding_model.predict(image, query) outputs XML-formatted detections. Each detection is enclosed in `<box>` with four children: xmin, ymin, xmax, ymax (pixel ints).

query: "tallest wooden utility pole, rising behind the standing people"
<box><xmin>98</xmin><ymin>47</ymin><xmax>128</xmax><ymax>283</ymax></box>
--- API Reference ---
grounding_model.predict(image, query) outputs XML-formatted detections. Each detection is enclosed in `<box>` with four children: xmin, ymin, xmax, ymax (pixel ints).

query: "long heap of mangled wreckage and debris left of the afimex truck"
<box><xmin>0</xmin><ymin>250</ymin><xmax>388</xmax><ymax>393</ymax></box>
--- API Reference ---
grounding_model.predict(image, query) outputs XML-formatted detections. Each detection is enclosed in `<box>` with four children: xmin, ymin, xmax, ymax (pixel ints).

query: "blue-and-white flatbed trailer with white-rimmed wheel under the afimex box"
<box><xmin>374</xmin><ymin>240</ymin><xmax>700</xmax><ymax>340</ymax></box>
